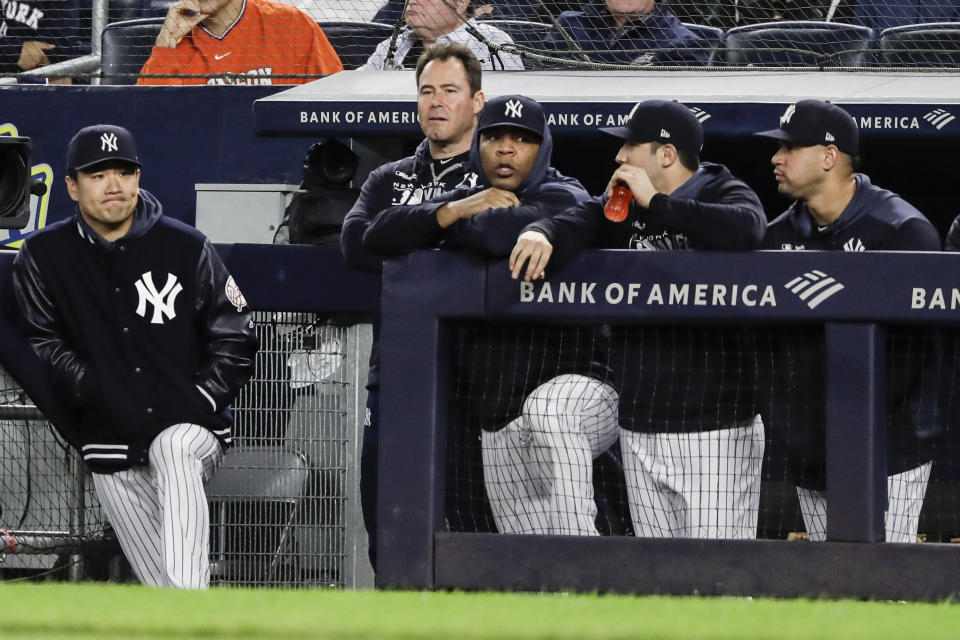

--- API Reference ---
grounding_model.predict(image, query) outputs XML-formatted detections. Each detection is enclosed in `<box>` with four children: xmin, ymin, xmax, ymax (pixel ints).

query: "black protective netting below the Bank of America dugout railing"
<box><xmin>446</xmin><ymin>323</ymin><xmax>960</xmax><ymax>542</ymax></box>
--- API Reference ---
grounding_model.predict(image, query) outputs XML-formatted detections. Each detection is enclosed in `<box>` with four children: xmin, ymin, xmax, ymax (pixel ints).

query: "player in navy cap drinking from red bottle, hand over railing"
<box><xmin>509</xmin><ymin>100</ymin><xmax>766</xmax><ymax>538</ymax></box>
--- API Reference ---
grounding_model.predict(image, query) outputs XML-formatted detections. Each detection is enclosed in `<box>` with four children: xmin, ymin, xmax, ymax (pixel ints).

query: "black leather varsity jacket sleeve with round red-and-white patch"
<box><xmin>196</xmin><ymin>240</ymin><xmax>259</xmax><ymax>412</ymax></box>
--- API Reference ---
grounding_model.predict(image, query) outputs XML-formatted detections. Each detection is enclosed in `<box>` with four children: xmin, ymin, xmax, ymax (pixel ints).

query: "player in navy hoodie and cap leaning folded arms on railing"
<box><xmin>363</xmin><ymin>95</ymin><xmax>617</xmax><ymax>535</ymax></box>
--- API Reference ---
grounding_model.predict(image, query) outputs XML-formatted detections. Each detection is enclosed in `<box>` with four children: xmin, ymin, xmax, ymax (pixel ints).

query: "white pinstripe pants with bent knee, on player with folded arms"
<box><xmin>481</xmin><ymin>374</ymin><xmax>618</xmax><ymax>535</ymax></box>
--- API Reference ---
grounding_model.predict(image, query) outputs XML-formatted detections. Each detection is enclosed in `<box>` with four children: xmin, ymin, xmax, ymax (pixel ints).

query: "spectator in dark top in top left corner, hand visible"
<box><xmin>0</xmin><ymin>0</ymin><xmax>80</xmax><ymax>84</ymax></box>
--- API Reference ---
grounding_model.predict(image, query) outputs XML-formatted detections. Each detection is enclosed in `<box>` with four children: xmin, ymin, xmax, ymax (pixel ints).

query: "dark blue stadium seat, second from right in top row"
<box><xmin>723</xmin><ymin>20</ymin><xmax>874</xmax><ymax>67</ymax></box>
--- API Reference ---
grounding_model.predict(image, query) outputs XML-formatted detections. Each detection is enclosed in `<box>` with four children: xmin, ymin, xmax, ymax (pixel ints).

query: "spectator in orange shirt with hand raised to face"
<box><xmin>137</xmin><ymin>0</ymin><xmax>343</xmax><ymax>85</ymax></box>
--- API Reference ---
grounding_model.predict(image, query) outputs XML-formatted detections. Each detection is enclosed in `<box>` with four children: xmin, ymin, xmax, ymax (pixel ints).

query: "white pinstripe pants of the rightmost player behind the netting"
<box><xmin>797</xmin><ymin>462</ymin><xmax>933</xmax><ymax>542</ymax></box>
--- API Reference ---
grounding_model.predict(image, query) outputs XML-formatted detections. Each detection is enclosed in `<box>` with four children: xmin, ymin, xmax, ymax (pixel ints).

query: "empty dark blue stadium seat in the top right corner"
<box><xmin>880</xmin><ymin>22</ymin><xmax>960</xmax><ymax>68</ymax></box>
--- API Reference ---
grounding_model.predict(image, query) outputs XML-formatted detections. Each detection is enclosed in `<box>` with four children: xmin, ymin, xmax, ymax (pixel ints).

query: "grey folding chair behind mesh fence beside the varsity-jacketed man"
<box><xmin>206</xmin><ymin>446</ymin><xmax>310</xmax><ymax>584</ymax></box>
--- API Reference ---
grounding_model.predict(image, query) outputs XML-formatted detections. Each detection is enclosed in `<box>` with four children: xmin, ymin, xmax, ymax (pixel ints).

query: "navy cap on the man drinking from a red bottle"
<box><xmin>600</xmin><ymin>100</ymin><xmax>703</xmax><ymax>153</ymax></box>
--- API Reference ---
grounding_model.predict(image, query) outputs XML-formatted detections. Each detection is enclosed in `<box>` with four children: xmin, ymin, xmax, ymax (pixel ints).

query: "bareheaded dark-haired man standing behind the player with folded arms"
<box><xmin>340</xmin><ymin>42</ymin><xmax>484</xmax><ymax>570</ymax></box>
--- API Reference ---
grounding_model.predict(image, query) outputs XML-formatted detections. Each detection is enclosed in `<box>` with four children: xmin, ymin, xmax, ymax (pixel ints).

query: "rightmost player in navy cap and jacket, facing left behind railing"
<box><xmin>757</xmin><ymin>100</ymin><xmax>945</xmax><ymax>542</ymax></box>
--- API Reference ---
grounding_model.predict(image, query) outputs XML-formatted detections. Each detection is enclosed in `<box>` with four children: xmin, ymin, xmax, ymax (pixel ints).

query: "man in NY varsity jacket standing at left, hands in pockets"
<box><xmin>13</xmin><ymin>125</ymin><xmax>257</xmax><ymax>589</ymax></box>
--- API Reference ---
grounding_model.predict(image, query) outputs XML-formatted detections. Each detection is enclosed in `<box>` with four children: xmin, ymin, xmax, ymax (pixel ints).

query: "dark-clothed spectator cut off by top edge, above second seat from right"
<box><xmin>669</xmin><ymin>0</ymin><xmax>856</xmax><ymax>29</ymax></box>
